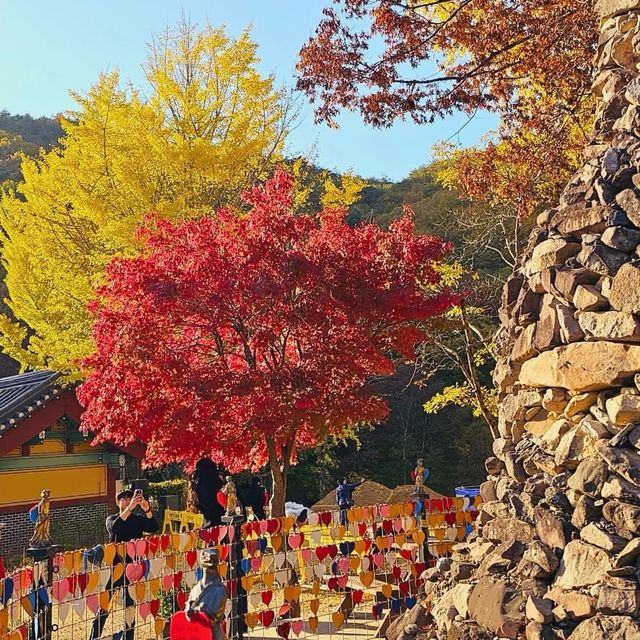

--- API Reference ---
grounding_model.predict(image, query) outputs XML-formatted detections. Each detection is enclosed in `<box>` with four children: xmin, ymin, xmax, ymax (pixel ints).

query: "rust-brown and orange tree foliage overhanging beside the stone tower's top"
<box><xmin>298</xmin><ymin>0</ymin><xmax>596</xmax><ymax>215</ymax></box>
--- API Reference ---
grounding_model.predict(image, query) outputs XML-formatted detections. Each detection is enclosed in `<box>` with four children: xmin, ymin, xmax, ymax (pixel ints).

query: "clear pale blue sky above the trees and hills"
<box><xmin>0</xmin><ymin>0</ymin><xmax>494</xmax><ymax>180</ymax></box>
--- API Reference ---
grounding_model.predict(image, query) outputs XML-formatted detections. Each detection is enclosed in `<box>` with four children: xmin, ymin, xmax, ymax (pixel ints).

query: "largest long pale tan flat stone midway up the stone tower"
<box><xmin>519</xmin><ymin>340</ymin><xmax>640</xmax><ymax>391</ymax></box>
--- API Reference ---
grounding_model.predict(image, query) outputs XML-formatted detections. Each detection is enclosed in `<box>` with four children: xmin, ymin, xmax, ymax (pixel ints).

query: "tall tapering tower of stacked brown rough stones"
<box><xmin>412</xmin><ymin>0</ymin><xmax>640</xmax><ymax>640</ymax></box>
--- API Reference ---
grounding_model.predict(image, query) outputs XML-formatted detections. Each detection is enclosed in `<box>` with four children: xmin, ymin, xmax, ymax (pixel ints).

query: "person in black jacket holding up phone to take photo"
<box><xmin>89</xmin><ymin>489</ymin><xmax>160</xmax><ymax>640</ymax></box>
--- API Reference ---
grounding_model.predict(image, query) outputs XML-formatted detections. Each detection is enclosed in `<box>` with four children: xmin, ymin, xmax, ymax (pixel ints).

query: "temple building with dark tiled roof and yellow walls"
<box><xmin>0</xmin><ymin>370</ymin><xmax>144</xmax><ymax>557</ymax></box>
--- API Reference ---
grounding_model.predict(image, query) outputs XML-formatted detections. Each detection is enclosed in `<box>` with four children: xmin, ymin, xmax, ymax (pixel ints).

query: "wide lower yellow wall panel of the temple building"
<box><xmin>0</xmin><ymin>464</ymin><xmax>107</xmax><ymax>507</ymax></box>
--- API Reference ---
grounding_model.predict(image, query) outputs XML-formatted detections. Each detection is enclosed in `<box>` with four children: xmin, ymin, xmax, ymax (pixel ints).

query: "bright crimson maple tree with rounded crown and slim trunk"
<box><xmin>78</xmin><ymin>172</ymin><xmax>455</xmax><ymax>515</ymax></box>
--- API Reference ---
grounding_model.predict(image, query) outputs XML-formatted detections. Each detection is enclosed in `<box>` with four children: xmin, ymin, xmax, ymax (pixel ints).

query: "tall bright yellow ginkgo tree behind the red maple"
<box><xmin>0</xmin><ymin>21</ymin><xmax>291</xmax><ymax>378</ymax></box>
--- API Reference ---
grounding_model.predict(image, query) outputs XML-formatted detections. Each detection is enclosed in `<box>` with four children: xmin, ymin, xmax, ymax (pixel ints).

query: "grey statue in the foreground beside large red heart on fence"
<box><xmin>185</xmin><ymin>549</ymin><xmax>228</xmax><ymax>640</ymax></box>
